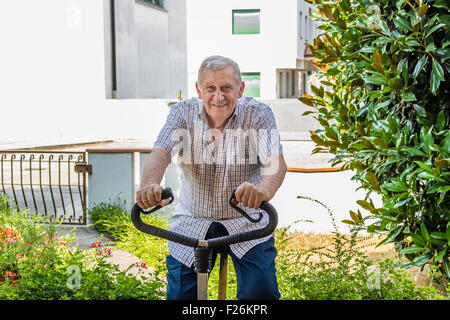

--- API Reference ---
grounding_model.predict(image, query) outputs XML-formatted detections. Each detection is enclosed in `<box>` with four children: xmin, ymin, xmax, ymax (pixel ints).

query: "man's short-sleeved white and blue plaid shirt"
<box><xmin>154</xmin><ymin>97</ymin><xmax>282</xmax><ymax>267</ymax></box>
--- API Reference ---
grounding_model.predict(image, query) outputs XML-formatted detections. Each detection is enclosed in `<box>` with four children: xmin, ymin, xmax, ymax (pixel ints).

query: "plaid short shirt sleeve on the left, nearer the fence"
<box><xmin>153</xmin><ymin>102</ymin><xmax>186</xmax><ymax>158</ymax></box>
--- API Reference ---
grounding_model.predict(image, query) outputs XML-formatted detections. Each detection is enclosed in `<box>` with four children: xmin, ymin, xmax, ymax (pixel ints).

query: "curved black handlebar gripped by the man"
<box><xmin>131</xmin><ymin>188</ymin><xmax>278</xmax><ymax>247</ymax></box>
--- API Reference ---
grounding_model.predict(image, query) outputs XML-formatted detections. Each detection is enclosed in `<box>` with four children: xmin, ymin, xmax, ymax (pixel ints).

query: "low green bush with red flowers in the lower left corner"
<box><xmin>0</xmin><ymin>198</ymin><xmax>164</xmax><ymax>300</ymax></box>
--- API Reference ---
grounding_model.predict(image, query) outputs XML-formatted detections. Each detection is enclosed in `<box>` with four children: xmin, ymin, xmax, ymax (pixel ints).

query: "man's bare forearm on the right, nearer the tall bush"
<box><xmin>259</xmin><ymin>154</ymin><xmax>287</xmax><ymax>201</ymax></box>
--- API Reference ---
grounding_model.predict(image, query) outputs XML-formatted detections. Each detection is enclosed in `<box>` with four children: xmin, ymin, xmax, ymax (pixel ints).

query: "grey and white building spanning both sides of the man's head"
<box><xmin>104</xmin><ymin>0</ymin><xmax>318</xmax><ymax>100</ymax></box>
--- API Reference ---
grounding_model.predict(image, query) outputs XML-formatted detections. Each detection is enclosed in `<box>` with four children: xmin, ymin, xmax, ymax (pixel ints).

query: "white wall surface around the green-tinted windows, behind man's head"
<box><xmin>186</xmin><ymin>0</ymin><xmax>298</xmax><ymax>99</ymax></box>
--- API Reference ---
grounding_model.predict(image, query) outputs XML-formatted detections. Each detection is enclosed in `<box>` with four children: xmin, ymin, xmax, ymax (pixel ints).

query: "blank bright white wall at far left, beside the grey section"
<box><xmin>0</xmin><ymin>0</ymin><xmax>169</xmax><ymax>144</ymax></box>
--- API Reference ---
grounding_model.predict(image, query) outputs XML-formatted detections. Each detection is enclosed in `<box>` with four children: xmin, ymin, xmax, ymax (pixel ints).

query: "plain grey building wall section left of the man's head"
<box><xmin>104</xmin><ymin>0</ymin><xmax>187</xmax><ymax>99</ymax></box>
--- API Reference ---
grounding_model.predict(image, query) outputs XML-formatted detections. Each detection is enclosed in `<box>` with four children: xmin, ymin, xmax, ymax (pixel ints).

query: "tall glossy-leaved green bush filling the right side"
<box><xmin>300</xmin><ymin>0</ymin><xmax>450</xmax><ymax>279</ymax></box>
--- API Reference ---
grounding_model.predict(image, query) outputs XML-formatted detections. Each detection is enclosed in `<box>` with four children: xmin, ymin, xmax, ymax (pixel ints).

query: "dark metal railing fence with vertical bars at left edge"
<box><xmin>0</xmin><ymin>150</ymin><xmax>89</xmax><ymax>225</ymax></box>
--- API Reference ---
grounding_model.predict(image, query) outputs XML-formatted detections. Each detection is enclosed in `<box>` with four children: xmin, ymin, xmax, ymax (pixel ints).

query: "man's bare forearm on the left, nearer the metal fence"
<box><xmin>141</xmin><ymin>147</ymin><xmax>170</xmax><ymax>188</ymax></box>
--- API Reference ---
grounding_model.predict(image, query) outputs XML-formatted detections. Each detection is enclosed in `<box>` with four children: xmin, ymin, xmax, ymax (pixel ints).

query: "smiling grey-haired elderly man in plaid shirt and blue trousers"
<box><xmin>136</xmin><ymin>56</ymin><xmax>286</xmax><ymax>300</ymax></box>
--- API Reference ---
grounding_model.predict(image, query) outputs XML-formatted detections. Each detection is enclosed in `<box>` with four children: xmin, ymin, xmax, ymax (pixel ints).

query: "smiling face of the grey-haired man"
<box><xmin>195</xmin><ymin>66</ymin><xmax>244</xmax><ymax>127</ymax></box>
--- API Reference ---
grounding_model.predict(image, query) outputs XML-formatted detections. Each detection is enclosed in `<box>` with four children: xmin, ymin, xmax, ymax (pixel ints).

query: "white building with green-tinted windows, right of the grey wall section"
<box><xmin>186</xmin><ymin>0</ymin><xmax>318</xmax><ymax>99</ymax></box>
